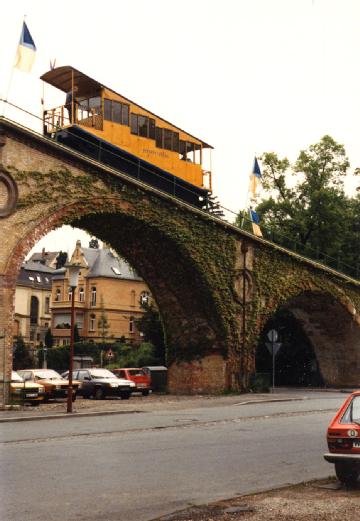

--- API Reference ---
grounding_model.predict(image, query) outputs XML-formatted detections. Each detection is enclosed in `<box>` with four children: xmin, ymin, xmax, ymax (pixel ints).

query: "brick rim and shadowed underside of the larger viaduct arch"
<box><xmin>4</xmin><ymin>196</ymin><xmax>239</xmax><ymax>392</ymax></box>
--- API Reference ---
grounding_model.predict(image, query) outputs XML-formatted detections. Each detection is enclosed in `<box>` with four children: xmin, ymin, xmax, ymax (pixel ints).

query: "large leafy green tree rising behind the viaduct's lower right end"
<box><xmin>237</xmin><ymin>136</ymin><xmax>352</xmax><ymax>259</ymax></box>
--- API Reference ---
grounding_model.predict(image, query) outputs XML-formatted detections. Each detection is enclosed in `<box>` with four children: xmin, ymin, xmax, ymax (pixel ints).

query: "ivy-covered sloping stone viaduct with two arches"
<box><xmin>0</xmin><ymin>117</ymin><xmax>360</xmax><ymax>405</ymax></box>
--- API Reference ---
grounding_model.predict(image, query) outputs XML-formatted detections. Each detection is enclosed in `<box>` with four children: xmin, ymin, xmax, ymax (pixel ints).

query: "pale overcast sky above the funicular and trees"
<box><xmin>0</xmin><ymin>0</ymin><xmax>360</xmax><ymax>255</ymax></box>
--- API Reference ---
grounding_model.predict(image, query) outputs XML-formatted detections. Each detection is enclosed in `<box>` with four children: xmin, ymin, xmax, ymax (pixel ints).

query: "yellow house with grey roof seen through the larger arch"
<box><xmin>51</xmin><ymin>241</ymin><xmax>151</xmax><ymax>345</ymax></box>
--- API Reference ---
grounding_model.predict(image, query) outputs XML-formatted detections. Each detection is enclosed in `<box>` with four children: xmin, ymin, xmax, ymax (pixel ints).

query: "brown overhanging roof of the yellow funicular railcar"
<box><xmin>40</xmin><ymin>65</ymin><xmax>214</xmax><ymax>148</ymax></box>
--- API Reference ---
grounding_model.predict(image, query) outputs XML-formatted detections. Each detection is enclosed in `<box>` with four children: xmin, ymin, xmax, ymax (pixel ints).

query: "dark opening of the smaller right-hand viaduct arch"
<box><xmin>255</xmin><ymin>308</ymin><xmax>324</xmax><ymax>387</ymax></box>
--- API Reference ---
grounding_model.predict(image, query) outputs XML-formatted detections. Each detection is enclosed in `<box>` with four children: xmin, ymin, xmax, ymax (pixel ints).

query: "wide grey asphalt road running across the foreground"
<box><xmin>0</xmin><ymin>393</ymin><xmax>345</xmax><ymax>521</ymax></box>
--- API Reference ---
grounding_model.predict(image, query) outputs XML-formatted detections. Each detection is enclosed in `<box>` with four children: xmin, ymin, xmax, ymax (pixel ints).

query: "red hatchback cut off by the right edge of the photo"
<box><xmin>324</xmin><ymin>391</ymin><xmax>360</xmax><ymax>485</ymax></box>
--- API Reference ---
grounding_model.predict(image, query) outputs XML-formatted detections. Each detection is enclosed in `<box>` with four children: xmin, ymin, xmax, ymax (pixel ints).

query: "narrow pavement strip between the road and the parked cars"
<box><xmin>0</xmin><ymin>388</ymin><xmax>351</xmax><ymax>423</ymax></box>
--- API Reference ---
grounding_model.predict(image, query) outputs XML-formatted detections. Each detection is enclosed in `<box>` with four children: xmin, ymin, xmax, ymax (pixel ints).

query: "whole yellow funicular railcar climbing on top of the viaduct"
<box><xmin>41</xmin><ymin>66</ymin><xmax>213</xmax><ymax>208</ymax></box>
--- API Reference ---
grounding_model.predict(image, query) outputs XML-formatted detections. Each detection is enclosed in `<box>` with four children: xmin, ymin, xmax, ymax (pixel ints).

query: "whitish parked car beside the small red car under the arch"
<box><xmin>63</xmin><ymin>368</ymin><xmax>135</xmax><ymax>400</ymax></box>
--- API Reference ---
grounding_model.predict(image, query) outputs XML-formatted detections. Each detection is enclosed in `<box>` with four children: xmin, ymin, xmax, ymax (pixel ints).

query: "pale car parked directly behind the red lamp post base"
<box><xmin>18</xmin><ymin>369</ymin><xmax>79</xmax><ymax>401</ymax></box>
